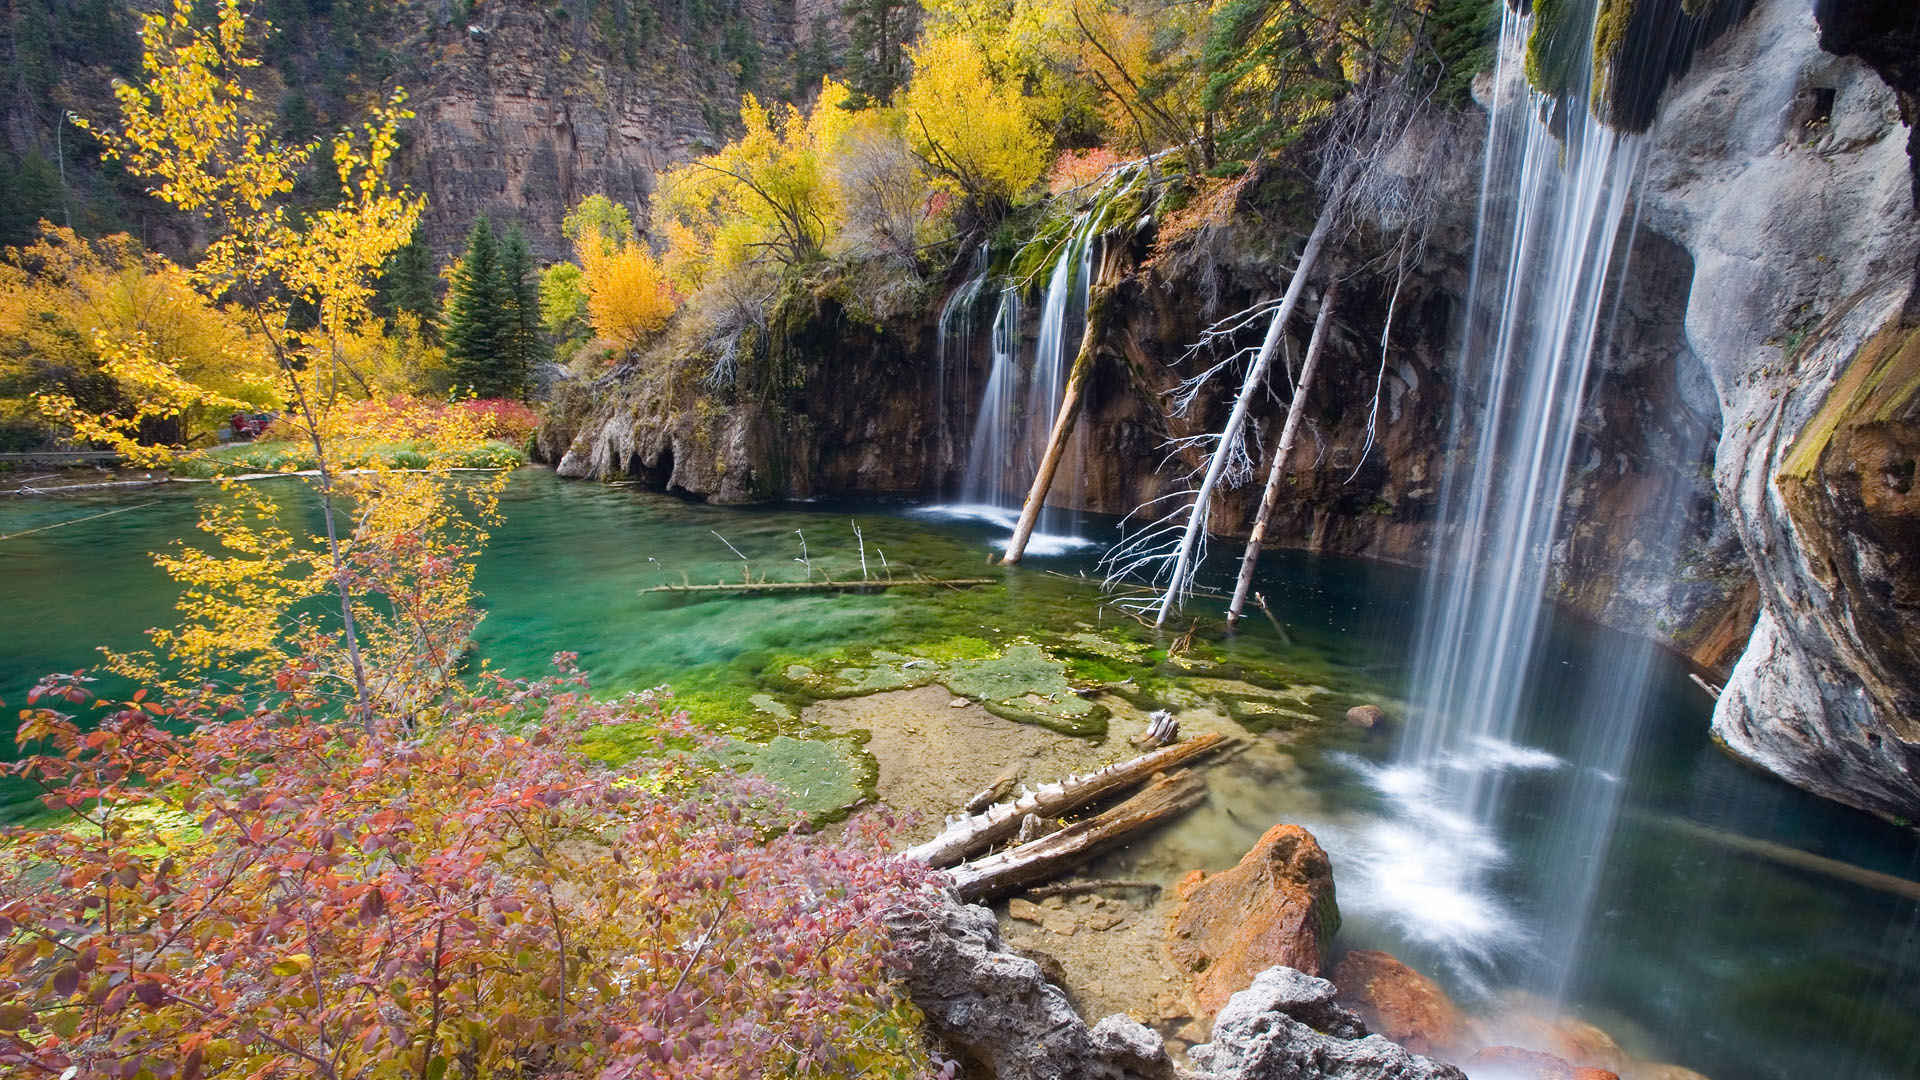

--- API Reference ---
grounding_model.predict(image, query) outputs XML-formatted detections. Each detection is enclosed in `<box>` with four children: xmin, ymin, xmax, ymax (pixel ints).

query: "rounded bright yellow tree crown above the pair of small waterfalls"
<box><xmin>899</xmin><ymin>31</ymin><xmax>1048</xmax><ymax>200</ymax></box>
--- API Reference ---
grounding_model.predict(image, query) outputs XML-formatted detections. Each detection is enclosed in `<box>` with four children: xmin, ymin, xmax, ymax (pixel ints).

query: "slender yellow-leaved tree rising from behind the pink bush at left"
<box><xmin>72</xmin><ymin>0</ymin><xmax>514</xmax><ymax>724</ymax></box>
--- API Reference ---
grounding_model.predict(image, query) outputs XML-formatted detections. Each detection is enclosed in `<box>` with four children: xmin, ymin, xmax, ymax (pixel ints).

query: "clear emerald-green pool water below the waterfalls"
<box><xmin>0</xmin><ymin>469</ymin><xmax>1920</xmax><ymax>1080</ymax></box>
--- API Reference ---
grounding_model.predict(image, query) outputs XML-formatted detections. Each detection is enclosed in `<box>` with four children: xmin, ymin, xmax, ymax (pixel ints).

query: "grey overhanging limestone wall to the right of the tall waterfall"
<box><xmin>1645</xmin><ymin>0</ymin><xmax>1920</xmax><ymax>821</ymax></box>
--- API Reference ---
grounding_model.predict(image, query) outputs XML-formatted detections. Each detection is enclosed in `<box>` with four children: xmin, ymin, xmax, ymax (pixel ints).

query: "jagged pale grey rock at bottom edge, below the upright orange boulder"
<box><xmin>1187</xmin><ymin>967</ymin><xmax>1467</xmax><ymax>1080</ymax></box>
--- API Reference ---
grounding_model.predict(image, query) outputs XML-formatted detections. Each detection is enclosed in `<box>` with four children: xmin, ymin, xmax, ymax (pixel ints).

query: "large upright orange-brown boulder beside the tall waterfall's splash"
<box><xmin>1167</xmin><ymin>824</ymin><xmax>1340</xmax><ymax>1015</ymax></box>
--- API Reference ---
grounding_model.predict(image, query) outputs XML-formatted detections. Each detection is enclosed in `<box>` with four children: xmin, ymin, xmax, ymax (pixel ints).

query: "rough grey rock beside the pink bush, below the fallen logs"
<box><xmin>891</xmin><ymin>892</ymin><xmax>1173</xmax><ymax>1080</ymax></box>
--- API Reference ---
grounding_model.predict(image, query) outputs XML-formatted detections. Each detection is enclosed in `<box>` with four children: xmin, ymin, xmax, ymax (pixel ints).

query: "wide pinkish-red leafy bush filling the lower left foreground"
<box><xmin>0</xmin><ymin>653</ymin><xmax>950</xmax><ymax>1080</ymax></box>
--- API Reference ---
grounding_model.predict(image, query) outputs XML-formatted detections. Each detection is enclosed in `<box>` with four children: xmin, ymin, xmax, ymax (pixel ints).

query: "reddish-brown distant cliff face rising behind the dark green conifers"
<box><xmin>399</xmin><ymin>0</ymin><xmax>793</xmax><ymax>259</ymax></box>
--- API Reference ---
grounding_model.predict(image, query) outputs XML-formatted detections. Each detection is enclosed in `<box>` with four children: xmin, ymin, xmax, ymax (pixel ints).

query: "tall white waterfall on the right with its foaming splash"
<box><xmin>1356</xmin><ymin>4</ymin><xmax>1681</xmax><ymax>994</ymax></box>
